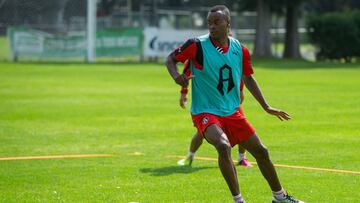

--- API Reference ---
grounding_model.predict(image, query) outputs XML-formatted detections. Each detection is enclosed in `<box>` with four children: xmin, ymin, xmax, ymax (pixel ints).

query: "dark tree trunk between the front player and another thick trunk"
<box><xmin>253</xmin><ymin>0</ymin><xmax>272</xmax><ymax>57</ymax></box>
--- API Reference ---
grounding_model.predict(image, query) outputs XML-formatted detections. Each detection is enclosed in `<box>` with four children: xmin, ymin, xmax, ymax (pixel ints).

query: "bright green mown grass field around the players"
<box><xmin>0</xmin><ymin>61</ymin><xmax>360</xmax><ymax>203</ymax></box>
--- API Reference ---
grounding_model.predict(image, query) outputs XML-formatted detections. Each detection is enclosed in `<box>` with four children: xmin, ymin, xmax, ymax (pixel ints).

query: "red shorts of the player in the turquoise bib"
<box><xmin>192</xmin><ymin>108</ymin><xmax>255</xmax><ymax>146</ymax></box>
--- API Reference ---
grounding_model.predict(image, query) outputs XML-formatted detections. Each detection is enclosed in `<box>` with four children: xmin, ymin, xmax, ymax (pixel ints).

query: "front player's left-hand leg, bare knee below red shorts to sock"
<box><xmin>205</xmin><ymin>124</ymin><xmax>243</xmax><ymax>202</ymax></box>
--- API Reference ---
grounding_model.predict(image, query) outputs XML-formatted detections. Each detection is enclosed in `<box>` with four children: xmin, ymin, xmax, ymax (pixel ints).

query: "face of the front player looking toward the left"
<box><xmin>207</xmin><ymin>12</ymin><xmax>230</xmax><ymax>39</ymax></box>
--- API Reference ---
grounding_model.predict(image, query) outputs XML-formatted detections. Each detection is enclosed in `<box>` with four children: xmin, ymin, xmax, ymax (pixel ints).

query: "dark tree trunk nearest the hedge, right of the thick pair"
<box><xmin>283</xmin><ymin>3</ymin><xmax>301</xmax><ymax>59</ymax></box>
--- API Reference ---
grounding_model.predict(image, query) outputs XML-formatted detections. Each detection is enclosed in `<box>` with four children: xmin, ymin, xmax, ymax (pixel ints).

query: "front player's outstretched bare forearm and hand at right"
<box><xmin>242</xmin><ymin>75</ymin><xmax>291</xmax><ymax>121</ymax></box>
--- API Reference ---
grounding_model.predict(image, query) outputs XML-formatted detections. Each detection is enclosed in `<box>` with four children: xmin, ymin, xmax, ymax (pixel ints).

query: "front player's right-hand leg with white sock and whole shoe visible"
<box><xmin>240</xmin><ymin>134</ymin><xmax>302</xmax><ymax>203</ymax></box>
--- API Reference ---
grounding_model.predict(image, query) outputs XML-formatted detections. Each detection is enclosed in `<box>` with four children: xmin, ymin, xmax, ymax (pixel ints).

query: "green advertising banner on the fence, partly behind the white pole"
<box><xmin>8</xmin><ymin>27</ymin><xmax>142</xmax><ymax>58</ymax></box>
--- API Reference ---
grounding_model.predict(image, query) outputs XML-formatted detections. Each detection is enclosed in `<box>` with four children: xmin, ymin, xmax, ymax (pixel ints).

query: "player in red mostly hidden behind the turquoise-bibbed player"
<box><xmin>177</xmin><ymin>59</ymin><xmax>252</xmax><ymax>167</ymax></box>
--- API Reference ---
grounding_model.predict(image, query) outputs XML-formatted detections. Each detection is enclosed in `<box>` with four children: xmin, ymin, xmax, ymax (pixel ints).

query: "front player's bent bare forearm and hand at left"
<box><xmin>166</xmin><ymin>53</ymin><xmax>194</xmax><ymax>87</ymax></box>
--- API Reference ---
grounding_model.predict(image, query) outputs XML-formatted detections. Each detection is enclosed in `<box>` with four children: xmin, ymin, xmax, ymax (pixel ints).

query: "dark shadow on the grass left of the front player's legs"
<box><xmin>140</xmin><ymin>166</ymin><xmax>217</xmax><ymax>176</ymax></box>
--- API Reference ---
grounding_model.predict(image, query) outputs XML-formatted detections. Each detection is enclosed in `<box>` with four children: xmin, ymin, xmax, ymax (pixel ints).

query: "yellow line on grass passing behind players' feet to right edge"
<box><xmin>168</xmin><ymin>156</ymin><xmax>360</xmax><ymax>174</ymax></box>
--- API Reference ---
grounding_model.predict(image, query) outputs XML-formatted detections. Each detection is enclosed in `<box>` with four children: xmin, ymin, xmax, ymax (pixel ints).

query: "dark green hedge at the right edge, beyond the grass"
<box><xmin>307</xmin><ymin>11</ymin><xmax>360</xmax><ymax>62</ymax></box>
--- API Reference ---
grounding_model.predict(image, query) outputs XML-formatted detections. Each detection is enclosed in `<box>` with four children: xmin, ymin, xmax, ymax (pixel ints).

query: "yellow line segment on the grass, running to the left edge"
<box><xmin>0</xmin><ymin>154</ymin><xmax>113</xmax><ymax>161</ymax></box>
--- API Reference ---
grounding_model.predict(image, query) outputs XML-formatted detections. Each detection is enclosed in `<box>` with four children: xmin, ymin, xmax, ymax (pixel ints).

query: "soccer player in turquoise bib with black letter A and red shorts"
<box><xmin>166</xmin><ymin>5</ymin><xmax>302</xmax><ymax>203</ymax></box>
